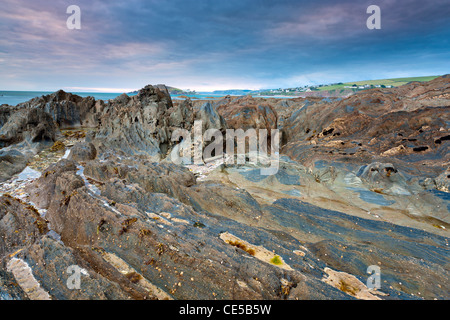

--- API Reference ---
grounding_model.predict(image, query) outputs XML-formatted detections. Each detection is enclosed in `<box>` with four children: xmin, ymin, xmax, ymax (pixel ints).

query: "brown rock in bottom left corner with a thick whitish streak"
<box><xmin>0</xmin><ymin>195</ymin><xmax>133</xmax><ymax>300</ymax></box>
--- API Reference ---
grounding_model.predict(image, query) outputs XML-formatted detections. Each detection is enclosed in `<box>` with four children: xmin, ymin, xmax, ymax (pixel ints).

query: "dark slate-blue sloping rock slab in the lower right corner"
<box><xmin>267</xmin><ymin>199</ymin><xmax>449</xmax><ymax>299</ymax></box>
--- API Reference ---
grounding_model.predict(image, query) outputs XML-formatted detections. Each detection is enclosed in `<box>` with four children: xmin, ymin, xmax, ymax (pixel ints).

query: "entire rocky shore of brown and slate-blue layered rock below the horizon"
<box><xmin>0</xmin><ymin>75</ymin><xmax>450</xmax><ymax>300</ymax></box>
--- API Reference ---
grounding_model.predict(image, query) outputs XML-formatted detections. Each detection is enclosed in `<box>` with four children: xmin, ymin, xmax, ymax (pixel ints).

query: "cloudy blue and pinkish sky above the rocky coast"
<box><xmin>0</xmin><ymin>0</ymin><xmax>450</xmax><ymax>92</ymax></box>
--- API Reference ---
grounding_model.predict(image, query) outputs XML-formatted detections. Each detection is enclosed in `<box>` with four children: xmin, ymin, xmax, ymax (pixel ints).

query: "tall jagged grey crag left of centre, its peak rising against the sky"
<box><xmin>89</xmin><ymin>86</ymin><xmax>225</xmax><ymax>160</ymax></box>
